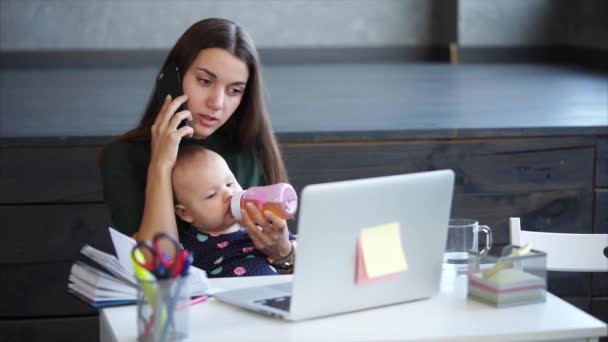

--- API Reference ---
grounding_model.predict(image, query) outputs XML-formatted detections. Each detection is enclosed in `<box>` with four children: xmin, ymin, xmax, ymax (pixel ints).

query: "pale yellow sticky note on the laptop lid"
<box><xmin>360</xmin><ymin>222</ymin><xmax>408</xmax><ymax>278</ymax></box>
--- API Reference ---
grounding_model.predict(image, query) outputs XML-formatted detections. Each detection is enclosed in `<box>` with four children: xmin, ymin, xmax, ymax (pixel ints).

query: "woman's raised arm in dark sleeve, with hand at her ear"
<box><xmin>101</xmin><ymin>96</ymin><xmax>192</xmax><ymax>240</ymax></box>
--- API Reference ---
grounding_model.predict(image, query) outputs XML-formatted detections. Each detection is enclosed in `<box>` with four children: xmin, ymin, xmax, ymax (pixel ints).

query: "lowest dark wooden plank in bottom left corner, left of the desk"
<box><xmin>0</xmin><ymin>315</ymin><xmax>99</xmax><ymax>342</ymax></box>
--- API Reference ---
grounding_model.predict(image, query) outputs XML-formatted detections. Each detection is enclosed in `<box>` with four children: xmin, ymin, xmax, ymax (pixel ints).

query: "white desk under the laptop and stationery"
<box><xmin>100</xmin><ymin>276</ymin><xmax>608</xmax><ymax>342</ymax></box>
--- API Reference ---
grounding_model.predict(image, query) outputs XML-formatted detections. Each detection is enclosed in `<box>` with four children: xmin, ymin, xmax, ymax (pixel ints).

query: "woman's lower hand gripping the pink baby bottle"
<box><xmin>239</xmin><ymin>203</ymin><xmax>292</xmax><ymax>260</ymax></box>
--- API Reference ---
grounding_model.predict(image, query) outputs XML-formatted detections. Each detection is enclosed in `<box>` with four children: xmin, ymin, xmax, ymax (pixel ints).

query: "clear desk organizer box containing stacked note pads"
<box><xmin>467</xmin><ymin>245</ymin><xmax>547</xmax><ymax>307</ymax></box>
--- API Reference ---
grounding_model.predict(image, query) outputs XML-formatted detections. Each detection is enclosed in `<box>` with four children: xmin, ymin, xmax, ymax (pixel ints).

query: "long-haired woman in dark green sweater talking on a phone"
<box><xmin>100</xmin><ymin>18</ymin><xmax>289</xmax><ymax>260</ymax></box>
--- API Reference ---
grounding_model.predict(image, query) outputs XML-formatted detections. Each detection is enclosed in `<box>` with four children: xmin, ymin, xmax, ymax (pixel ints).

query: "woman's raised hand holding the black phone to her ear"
<box><xmin>150</xmin><ymin>95</ymin><xmax>194</xmax><ymax>172</ymax></box>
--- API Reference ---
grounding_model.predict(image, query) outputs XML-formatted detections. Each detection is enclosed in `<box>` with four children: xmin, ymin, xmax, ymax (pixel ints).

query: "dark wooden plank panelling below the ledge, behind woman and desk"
<box><xmin>0</xmin><ymin>137</ymin><xmax>608</xmax><ymax>334</ymax></box>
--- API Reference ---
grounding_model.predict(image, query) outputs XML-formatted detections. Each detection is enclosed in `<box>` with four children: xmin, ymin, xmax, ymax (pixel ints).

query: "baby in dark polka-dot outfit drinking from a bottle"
<box><xmin>171</xmin><ymin>145</ymin><xmax>295</xmax><ymax>277</ymax></box>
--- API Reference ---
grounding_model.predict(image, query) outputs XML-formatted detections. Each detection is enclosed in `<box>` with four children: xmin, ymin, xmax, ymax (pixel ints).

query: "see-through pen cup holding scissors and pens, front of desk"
<box><xmin>137</xmin><ymin>276</ymin><xmax>190</xmax><ymax>342</ymax></box>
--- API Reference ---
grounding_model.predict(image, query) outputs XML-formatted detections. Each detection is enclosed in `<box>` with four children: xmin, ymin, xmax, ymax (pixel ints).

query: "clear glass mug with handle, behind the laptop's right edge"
<box><xmin>443</xmin><ymin>218</ymin><xmax>492</xmax><ymax>271</ymax></box>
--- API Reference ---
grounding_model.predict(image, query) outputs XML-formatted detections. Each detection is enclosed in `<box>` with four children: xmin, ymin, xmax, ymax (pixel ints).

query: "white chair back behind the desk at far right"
<box><xmin>509</xmin><ymin>217</ymin><xmax>608</xmax><ymax>272</ymax></box>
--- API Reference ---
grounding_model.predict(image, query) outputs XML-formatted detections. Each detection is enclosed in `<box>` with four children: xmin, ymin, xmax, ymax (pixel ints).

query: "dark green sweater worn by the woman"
<box><xmin>100</xmin><ymin>135</ymin><xmax>263</xmax><ymax>235</ymax></box>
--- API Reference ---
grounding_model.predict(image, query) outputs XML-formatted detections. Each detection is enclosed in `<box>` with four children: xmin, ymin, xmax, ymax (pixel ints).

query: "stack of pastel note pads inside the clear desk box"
<box><xmin>468</xmin><ymin>268</ymin><xmax>546</xmax><ymax>307</ymax></box>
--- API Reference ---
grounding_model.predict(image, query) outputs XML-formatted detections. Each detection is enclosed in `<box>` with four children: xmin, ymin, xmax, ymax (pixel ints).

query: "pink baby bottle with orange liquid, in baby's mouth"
<box><xmin>230</xmin><ymin>183</ymin><xmax>298</xmax><ymax>220</ymax></box>
